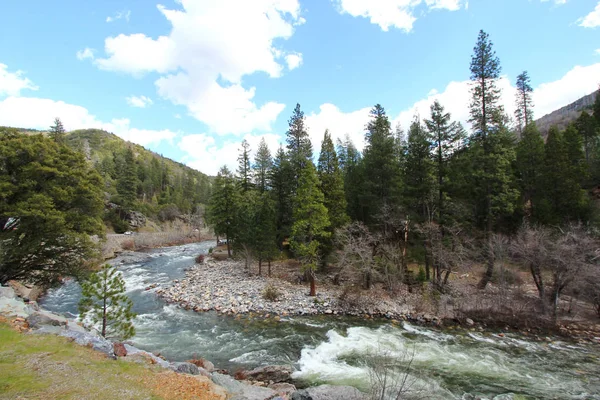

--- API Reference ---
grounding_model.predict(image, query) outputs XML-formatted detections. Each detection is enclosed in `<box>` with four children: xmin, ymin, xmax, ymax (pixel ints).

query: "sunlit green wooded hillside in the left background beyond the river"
<box><xmin>11</xmin><ymin>128</ymin><xmax>212</xmax><ymax>233</ymax></box>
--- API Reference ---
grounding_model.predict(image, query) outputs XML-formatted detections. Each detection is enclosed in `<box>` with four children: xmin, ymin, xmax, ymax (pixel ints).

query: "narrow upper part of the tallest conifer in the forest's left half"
<box><xmin>286</xmin><ymin>104</ymin><xmax>312</xmax><ymax>188</ymax></box>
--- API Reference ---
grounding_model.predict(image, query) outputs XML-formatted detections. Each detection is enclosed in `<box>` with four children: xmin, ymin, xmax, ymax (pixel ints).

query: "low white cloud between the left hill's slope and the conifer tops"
<box><xmin>178</xmin><ymin>133</ymin><xmax>281</xmax><ymax>175</ymax></box>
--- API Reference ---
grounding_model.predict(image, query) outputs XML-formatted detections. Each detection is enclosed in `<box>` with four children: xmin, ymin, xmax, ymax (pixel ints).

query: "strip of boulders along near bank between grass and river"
<box><xmin>0</xmin><ymin>284</ymin><xmax>367</xmax><ymax>400</ymax></box>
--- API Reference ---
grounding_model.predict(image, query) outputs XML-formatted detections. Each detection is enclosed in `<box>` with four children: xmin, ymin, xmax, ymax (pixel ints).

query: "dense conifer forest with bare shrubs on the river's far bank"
<box><xmin>208</xmin><ymin>31</ymin><xmax>600</xmax><ymax>319</ymax></box>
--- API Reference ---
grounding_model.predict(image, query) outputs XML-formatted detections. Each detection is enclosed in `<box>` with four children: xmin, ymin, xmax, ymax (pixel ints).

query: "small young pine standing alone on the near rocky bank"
<box><xmin>79</xmin><ymin>264</ymin><xmax>135</xmax><ymax>340</ymax></box>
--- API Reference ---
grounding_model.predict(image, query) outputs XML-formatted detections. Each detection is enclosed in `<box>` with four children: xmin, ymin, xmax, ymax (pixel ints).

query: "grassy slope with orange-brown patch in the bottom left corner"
<box><xmin>0</xmin><ymin>322</ymin><xmax>225</xmax><ymax>400</ymax></box>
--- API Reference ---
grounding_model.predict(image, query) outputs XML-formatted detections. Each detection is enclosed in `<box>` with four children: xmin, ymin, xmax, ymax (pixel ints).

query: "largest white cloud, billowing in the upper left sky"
<box><xmin>96</xmin><ymin>0</ymin><xmax>304</xmax><ymax>135</ymax></box>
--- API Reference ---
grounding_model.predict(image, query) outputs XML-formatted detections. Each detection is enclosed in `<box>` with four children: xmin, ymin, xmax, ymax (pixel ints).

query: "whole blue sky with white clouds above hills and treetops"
<box><xmin>0</xmin><ymin>0</ymin><xmax>600</xmax><ymax>175</ymax></box>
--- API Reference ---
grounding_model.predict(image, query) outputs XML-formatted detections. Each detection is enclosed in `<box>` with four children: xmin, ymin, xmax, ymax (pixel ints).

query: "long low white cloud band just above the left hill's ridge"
<box><xmin>0</xmin><ymin>96</ymin><xmax>176</xmax><ymax>146</ymax></box>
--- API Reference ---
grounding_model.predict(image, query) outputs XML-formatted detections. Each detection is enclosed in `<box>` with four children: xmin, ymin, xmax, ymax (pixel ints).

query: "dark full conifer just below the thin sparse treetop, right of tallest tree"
<box><xmin>516</xmin><ymin>123</ymin><xmax>545</xmax><ymax>223</ymax></box>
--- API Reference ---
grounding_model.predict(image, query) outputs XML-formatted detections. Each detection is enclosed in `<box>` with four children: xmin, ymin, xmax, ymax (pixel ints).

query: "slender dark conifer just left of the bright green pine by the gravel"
<box><xmin>270</xmin><ymin>147</ymin><xmax>294</xmax><ymax>248</ymax></box>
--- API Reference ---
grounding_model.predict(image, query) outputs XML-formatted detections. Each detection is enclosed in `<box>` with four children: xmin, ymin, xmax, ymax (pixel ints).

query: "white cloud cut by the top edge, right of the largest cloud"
<box><xmin>333</xmin><ymin>0</ymin><xmax>468</xmax><ymax>32</ymax></box>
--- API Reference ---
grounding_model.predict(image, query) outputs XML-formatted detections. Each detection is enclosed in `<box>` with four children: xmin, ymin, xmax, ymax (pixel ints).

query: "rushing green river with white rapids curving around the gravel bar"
<box><xmin>41</xmin><ymin>242</ymin><xmax>600</xmax><ymax>400</ymax></box>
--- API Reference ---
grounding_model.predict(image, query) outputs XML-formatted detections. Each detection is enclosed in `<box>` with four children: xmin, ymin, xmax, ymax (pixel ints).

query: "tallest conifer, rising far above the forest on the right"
<box><xmin>469</xmin><ymin>30</ymin><xmax>511</xmax><ymax>289</ymax></box>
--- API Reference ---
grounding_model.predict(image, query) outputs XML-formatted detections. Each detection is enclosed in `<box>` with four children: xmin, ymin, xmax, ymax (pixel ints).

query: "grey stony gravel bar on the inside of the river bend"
<box><xmin>155</xmin><ymin>257</ymin><xmax>441</xmax><ymax>324</ymax></box>
